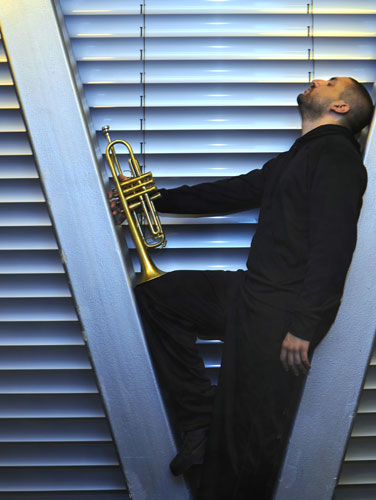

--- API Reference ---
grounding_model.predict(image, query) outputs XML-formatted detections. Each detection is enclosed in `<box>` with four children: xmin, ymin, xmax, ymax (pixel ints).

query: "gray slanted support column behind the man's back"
<box><xmin>275</xmin><ymin>112</ymin><xmax>376</xmax><ymax>500</ymax></box>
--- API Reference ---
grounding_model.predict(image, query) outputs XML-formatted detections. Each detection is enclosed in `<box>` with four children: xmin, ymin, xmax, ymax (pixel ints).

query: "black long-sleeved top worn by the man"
<box><xmin>156</xmin><ymin>125</ymin><xmax>367</xmax><ymax>340</ymax></box>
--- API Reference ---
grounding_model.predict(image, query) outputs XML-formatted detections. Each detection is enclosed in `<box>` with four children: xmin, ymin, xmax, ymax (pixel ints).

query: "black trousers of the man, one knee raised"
<box><xmin>136</xmin><ymin>271</ymin><xmax>304</xmax><ymax>500</ymax></box>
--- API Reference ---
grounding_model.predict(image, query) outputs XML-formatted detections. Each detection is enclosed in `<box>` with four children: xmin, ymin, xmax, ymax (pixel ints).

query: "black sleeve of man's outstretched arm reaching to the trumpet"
<box><xmin>155</xmin><ymin>165</ymin><xmax>266</xmax><ymax>215</ymax></box>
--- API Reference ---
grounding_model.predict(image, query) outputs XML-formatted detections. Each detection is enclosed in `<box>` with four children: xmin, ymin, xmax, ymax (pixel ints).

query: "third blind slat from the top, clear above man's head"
<box><xmin>72</xmin><ymin>36</ymin><xmax>375</xmax><ymax>61</ymax></box>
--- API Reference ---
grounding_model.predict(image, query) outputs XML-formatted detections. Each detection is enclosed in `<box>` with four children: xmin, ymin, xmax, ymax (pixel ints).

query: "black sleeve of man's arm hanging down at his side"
<box><xmin>289</xmin><ymin>146</ymin><xmax>367</xmax><ymax>340</ymax></box>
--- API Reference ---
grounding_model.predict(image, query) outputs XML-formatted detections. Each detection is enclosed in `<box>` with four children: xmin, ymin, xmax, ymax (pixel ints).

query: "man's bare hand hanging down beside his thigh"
<box><xmin>280</xmin><ymin>333</ymin><xmax>311</xmax><ymax>376</ymax></box>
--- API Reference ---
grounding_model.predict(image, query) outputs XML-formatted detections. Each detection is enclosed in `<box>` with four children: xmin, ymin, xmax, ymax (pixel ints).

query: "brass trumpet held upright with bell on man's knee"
<box><xmin>102</xmin><ymin>125</ymin><xmax>167</xmax><ymax>285</ymax></box>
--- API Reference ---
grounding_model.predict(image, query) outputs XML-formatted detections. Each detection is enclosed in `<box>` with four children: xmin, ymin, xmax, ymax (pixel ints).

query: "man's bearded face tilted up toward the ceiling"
<box><xmin>297</xmin><ymin>76</ymin><xmax>352</xmax><ymax>119</ymax></box>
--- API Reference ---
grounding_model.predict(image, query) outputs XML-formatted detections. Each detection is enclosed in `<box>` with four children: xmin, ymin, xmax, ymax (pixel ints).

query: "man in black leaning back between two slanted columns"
<box><xmin>111</xmin><ymin>77</ymin><xmax>372</xmax><ymax>500</ymax></box>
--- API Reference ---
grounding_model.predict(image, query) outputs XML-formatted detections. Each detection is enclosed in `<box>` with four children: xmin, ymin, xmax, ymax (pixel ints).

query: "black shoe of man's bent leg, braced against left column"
<box><xmin>170</xmin><ymin>427</ymin><xmax>208</xmax><ymax>476</ymax></box>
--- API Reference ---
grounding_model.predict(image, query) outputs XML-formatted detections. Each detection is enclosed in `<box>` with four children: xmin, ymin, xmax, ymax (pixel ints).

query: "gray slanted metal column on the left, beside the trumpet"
<box><xmin>0</xmin><ymin>0</ymin><xmax>190</xmax><ymax>500</ymax></box>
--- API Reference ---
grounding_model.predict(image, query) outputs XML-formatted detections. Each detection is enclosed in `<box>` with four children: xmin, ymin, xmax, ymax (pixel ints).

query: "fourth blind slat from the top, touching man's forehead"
<box><xmin>78</xmin><ymin>60</ymin><xmax>376</xmax><ymax>84</ymax></box>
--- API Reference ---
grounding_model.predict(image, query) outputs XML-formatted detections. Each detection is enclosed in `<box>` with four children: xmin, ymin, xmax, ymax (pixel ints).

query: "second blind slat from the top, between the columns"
<box><xmin>65</xmin><ymin>14</ymin><xmax>376</xmax><ymax>38</ymax></box>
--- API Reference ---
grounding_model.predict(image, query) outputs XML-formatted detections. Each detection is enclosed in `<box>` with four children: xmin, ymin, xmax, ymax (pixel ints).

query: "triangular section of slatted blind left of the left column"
<box><xmin>0</xmin><ymin>32</ymin><xmax>129</xmax><ymax>500</ymax></box>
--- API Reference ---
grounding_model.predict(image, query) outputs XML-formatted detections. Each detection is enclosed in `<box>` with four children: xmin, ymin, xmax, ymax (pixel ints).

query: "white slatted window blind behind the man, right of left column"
<box><xmin>60</xmin><ymin>0</ymin><xmax>376</xmax><ymax>494</ymax></box>
